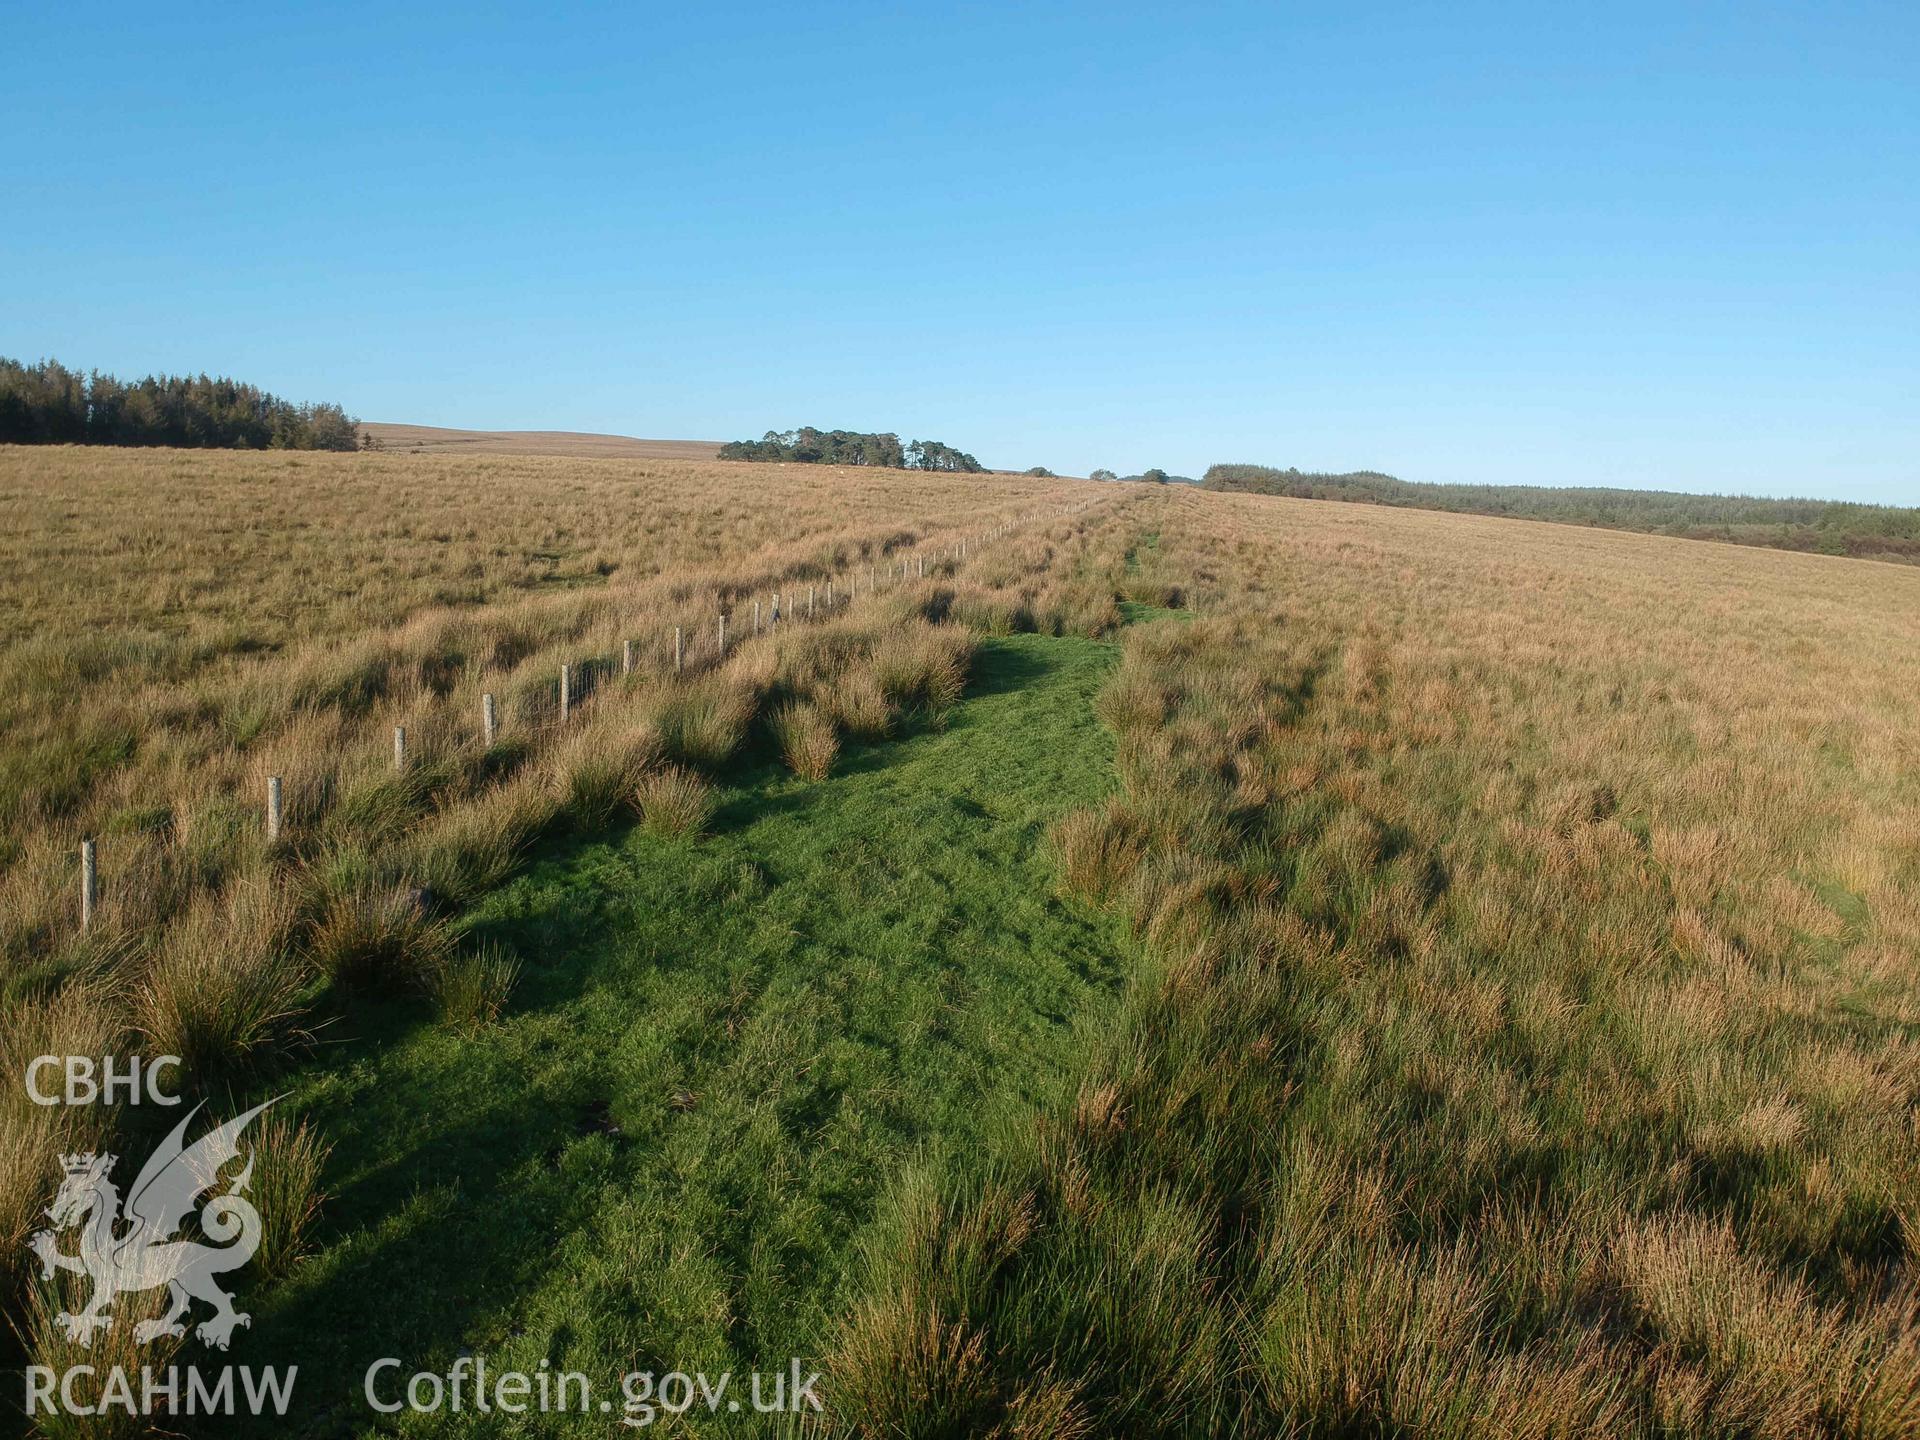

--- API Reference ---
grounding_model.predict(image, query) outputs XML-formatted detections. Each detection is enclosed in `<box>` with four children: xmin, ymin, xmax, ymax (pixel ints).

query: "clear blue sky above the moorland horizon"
<box><xmin>0</xmin><ymin>0</ymin><xmax>1920</xmax><ymax>503</ymax></box>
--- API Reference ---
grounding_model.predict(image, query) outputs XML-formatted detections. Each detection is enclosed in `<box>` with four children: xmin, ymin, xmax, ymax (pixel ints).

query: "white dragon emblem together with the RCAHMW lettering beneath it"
<box><xmin>27</xmin><ymin>1100</ymin><xmax>298</xmax><ymax>1415</ymax></box>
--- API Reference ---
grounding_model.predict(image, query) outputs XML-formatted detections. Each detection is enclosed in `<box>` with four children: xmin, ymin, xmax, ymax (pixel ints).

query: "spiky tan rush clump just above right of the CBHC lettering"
<box><xmin>132</xmin><ymin>877</ymin><xmax>307</xmax><ymax>1075</ymax></box>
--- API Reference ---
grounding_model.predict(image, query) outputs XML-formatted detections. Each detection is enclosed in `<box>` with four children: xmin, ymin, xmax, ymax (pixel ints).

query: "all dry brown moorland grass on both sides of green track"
<box><xmin>15</xmin><ymin>451</ymin><xmax>1920</xmax><ymax>1436</ymax></box>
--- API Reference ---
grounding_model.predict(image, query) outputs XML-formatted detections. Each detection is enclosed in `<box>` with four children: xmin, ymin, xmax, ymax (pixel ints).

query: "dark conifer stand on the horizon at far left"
<box><xmin>0</xmin><ymin>359</ymin><xmax>359</xmax><ymax>449</ymax></box>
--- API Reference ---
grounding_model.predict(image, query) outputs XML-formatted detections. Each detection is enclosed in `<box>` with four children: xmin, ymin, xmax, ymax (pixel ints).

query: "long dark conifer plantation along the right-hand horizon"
<box><xmin>1202</xmin><ymin>465</ymin><xmax>1920</xmax><ymax>561</ymax></box>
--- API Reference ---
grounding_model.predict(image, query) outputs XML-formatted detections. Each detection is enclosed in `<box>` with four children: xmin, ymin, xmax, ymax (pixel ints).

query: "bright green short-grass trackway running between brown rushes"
<box><xmin>234</xmin><ymin>636</ymin><xmax>1127</xmax><ymax>1434</ymax></box>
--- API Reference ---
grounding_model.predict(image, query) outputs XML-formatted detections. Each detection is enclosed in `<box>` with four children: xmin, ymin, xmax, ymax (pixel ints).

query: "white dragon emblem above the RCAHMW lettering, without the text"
<box><xmin>27</xmin><ymin>1096</ymin><xmax>278</xmax><ymax>1350</ymax></box>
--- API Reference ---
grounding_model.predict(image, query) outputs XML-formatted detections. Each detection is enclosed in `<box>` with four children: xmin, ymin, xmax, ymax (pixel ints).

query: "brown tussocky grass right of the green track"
<box><xmin>839</xmin><ymin>481</ymin><xmax>1920</xmax><ymax>1436</ymax></box>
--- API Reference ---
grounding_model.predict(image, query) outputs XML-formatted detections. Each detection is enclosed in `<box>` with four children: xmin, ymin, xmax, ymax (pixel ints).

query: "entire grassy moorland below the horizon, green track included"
<box><xmin>0</xmin><ymin>445</ymin><xmax>1920</xmax><ymax>1436</ymax></box>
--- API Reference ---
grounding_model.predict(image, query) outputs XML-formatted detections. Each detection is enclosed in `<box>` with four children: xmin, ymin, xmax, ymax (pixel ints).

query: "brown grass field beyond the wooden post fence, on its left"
<box><xmin>0</xmin><ymin>447</ymin><xmax>1071</xmax><ymax>952</ymax></box>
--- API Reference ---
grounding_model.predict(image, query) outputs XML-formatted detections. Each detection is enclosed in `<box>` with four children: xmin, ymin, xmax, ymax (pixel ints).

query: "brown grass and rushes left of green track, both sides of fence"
<box><xmin>0</xmin><ymin>447</ymin><xmax>1098</xmax><ymax>1313</ymax></box>
